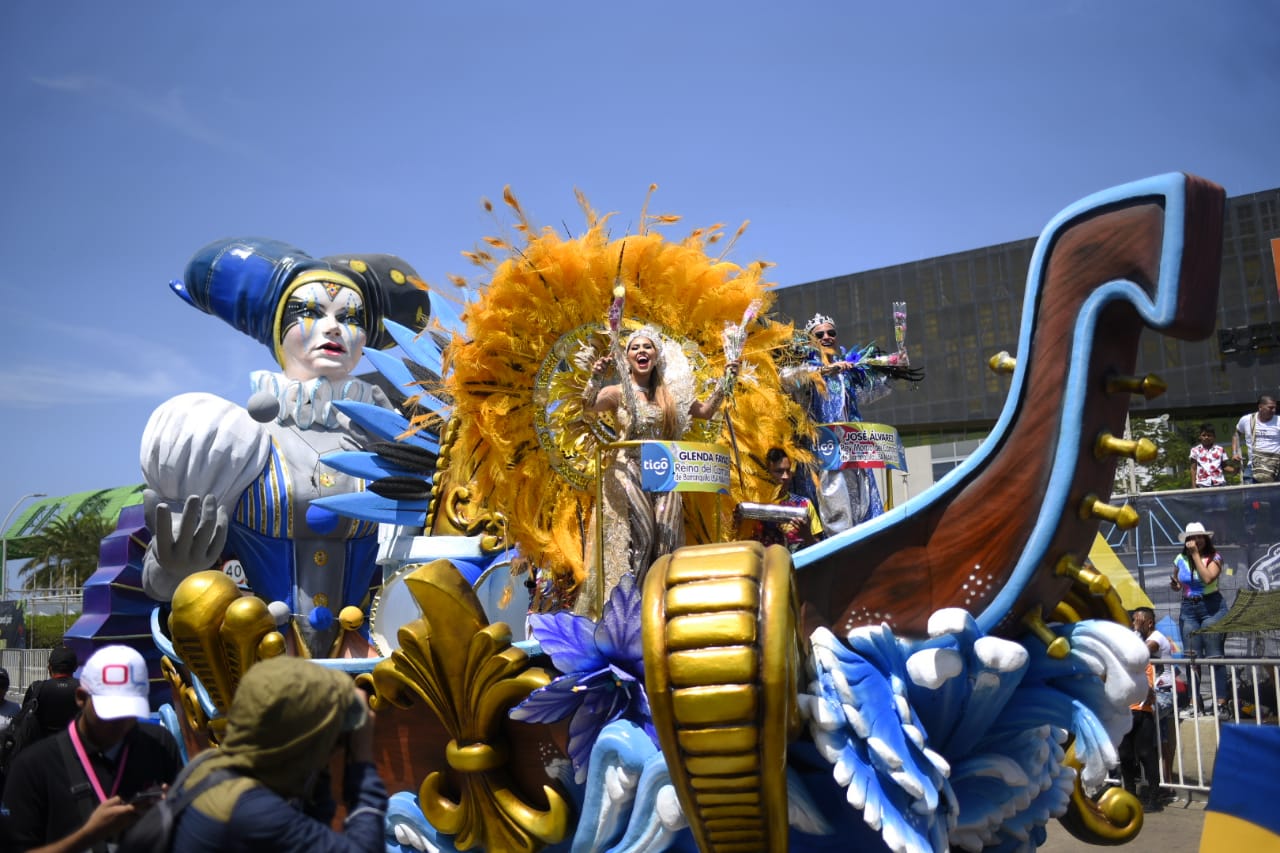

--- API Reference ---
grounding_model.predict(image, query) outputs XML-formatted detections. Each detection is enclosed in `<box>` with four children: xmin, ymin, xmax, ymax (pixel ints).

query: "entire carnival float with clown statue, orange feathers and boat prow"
<box><xmin>99</xmin><ymin>174</ymin><xmax>1224</xmax><ymax>853</ymax></box>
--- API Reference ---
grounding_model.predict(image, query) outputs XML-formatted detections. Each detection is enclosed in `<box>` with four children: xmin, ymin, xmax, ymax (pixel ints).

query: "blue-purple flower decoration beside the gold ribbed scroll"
<box><xmin>511</xmin><ymin>575</ymin><xmax>658</xmax><ymax>783</ymax></box>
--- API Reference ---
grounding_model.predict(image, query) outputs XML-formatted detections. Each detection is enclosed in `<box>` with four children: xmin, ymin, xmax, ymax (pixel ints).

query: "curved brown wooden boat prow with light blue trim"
<box><xmin>796</xmin><ymin>174</ymin><xmax>1225</xmax><ymax>637</ymax></box>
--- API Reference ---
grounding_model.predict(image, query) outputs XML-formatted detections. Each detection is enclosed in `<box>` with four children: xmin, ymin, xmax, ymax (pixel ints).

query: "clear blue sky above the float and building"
<box><xmin>0</xmin><ymin>0</ymin><xmax>1280</xmax><ymax>537</ymax></box>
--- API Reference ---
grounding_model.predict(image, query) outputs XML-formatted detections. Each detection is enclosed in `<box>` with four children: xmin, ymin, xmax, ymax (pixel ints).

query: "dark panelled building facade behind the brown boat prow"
<box><xmin>777</xmin><ymin>188</ymin><xmax>1280</xmax><ymax>440</ymax></box>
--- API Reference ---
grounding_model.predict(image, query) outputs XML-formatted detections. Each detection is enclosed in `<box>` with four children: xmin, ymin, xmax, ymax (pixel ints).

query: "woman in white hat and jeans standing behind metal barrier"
<box><xmin>1169</xmin><ymin>521</ymin><xmax>1228</xmax><ymax>716</ymax></box>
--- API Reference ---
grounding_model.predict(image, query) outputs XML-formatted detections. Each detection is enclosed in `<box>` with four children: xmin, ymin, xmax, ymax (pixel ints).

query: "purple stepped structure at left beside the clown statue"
<box><xmin>67</xmin><ymin>503</ymin><xmax>172</xmax><ymax>711</ymax></box>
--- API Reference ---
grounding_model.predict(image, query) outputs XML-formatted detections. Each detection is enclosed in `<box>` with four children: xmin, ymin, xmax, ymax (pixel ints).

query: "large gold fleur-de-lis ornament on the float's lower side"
<box><xmin>361</xmin><ymin>560</ymin><xmax>571</xmax><ymax>853</ymax></box>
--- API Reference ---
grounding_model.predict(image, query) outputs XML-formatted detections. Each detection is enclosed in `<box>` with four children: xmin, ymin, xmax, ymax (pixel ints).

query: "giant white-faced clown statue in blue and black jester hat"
<box><xmin>141</xmin><ymin>238</ymin><xmax>429</xmax><ymax>657</ymax></box>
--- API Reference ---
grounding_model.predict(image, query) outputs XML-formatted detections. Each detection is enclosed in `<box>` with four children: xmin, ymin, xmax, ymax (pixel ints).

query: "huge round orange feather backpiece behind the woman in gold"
<box><xmin>444</xmin><ymin>187</ymin><xmax>803</xmax><ymax>612</ymax></box>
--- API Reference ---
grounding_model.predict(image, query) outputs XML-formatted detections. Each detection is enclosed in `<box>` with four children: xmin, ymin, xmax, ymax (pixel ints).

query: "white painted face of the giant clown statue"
<box><xmin>280</xmin><ymin>282</ymin><xmax>366</xmax><ymax>382</ymax></box>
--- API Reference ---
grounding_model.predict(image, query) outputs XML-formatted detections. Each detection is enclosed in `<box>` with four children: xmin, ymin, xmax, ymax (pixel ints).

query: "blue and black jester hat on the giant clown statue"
<box><xmin>169</xmin><ymin>237</ymin><xmax>431</xmax><ymax>364</ymax></box>
